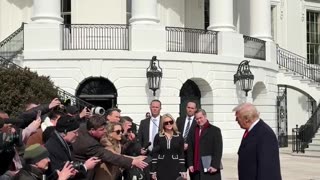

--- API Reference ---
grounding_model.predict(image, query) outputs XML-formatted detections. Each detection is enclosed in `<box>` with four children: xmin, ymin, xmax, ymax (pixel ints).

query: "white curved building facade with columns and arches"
<box><xmin>0</xmin><ymin>0</ymin><xmax>320</xmax><ymax>153</ymax></box>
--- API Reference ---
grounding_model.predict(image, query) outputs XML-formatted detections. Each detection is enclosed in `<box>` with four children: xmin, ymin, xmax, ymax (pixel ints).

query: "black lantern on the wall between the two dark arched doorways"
<box><xmin>147</xmin><ymin>56</ymin><xmax>162</xmax><ymax>96</ymax></box>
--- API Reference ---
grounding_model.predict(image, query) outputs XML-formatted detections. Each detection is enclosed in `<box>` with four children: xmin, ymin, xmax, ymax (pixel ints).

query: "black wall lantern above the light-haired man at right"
<box><xmin>233</xmin><ymin>60</ymin><xmax>254</xmax><ymax>96</ymax></box>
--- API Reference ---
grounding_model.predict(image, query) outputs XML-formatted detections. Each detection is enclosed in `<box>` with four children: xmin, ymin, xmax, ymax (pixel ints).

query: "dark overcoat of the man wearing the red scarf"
<box><xmin>188</xmin><ymin>124</ymin><xmax>223</xmax><ymax>180</ymax></box>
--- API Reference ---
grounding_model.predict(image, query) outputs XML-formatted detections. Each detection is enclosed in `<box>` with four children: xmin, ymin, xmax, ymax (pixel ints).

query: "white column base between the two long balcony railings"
<box><xmin>130</xmin><ymin>0</ymin><xmax>159</xmax><ymax>24</ymax></box>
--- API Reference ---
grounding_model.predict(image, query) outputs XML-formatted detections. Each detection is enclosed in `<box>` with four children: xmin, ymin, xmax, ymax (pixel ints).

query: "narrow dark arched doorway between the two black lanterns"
<box><xmin>179</xmin><ymin>79</ymin><xmax>201</xmax><ymax>116</ymax></box>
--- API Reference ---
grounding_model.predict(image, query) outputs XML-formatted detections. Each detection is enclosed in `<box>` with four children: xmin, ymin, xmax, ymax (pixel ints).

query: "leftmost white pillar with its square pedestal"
<box><xmin>24</xmin><ymin>0</ymin><xmax>63</xmax><ymax>52</ymax></box>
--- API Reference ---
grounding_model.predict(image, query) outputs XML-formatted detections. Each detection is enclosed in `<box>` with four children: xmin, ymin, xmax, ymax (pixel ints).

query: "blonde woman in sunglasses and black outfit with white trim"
<box><xmin>151</xmin><ymin>114</ymin><xmax>187</xmax><ymax>180</ymax></box>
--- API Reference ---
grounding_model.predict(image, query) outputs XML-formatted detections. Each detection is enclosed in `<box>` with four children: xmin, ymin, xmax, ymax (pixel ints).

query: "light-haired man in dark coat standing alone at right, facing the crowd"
<box><xmin>234</xmin><ymin>103</ymin><xmax>281</xmax><ymax>180</ymax></box>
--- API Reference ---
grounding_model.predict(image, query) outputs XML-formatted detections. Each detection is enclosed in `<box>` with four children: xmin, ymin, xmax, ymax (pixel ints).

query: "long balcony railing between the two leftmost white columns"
<box><xmin>62</xmin><ymin>24</ymin><xmax>129</xmax><ymax>50</ymax></box>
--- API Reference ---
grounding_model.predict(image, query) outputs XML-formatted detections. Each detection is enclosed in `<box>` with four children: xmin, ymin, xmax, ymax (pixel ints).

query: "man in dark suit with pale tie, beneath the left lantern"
<box><xmin>138</xmin><ymin>99</ymin><xmax>161</xmax><ymax>154</ymax></box>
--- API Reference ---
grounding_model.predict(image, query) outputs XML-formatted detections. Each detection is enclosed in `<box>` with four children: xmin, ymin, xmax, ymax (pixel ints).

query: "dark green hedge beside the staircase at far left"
<box><xmin>0</xmin><ymin>67</ymin><xmax>57</xmax><ymax>117</ymax></box>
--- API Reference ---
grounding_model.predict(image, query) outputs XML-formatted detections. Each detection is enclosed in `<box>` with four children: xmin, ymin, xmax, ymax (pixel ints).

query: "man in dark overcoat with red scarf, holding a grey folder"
<box><xmin>188</xmin><ymin>109</ymin><xmax>223</xmax><ymax>180</ymax></box>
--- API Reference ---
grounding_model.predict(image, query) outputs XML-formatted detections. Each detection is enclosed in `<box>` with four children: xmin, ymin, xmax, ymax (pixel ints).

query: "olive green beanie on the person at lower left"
<box><xmin>23</xmin><ymin>144</ymin><xmax>49</xmax><ymax>164</ymax></box>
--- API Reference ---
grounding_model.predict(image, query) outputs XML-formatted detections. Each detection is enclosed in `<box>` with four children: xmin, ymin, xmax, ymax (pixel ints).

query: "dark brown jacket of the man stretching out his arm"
<box><xmin>72</xmin><ymin>127</ymin><xmax>133</xmax><ymax>179</ymax></box>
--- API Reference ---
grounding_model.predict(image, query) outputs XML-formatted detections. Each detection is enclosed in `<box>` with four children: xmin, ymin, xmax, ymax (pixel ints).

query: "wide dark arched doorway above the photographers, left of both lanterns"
<box><xmin>76</xmin><ymin>77</ymin><xmax>117</xmax><ymax>109</ymax></box>
